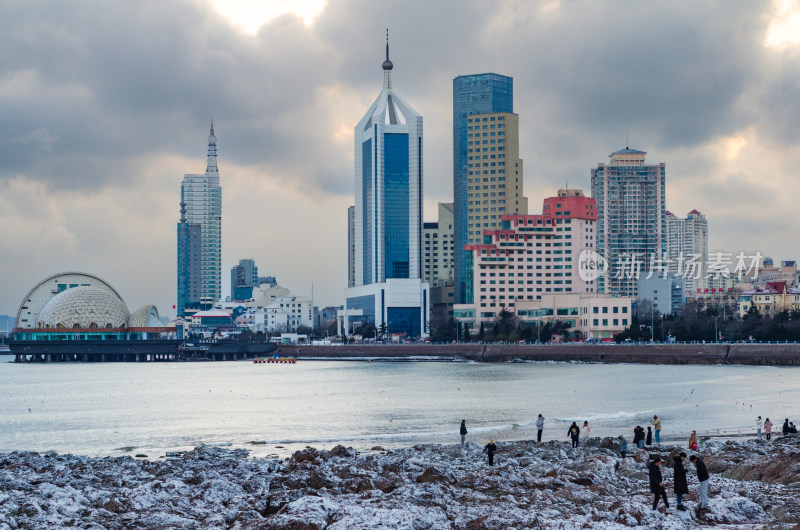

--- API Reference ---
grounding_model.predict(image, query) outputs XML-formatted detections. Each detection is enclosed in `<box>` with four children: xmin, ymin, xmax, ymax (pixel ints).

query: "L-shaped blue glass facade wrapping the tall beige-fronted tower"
<box><xmin>453</xmin><ymin>74</ymin><xmax>514</xmax><ymax>304</ymax></box>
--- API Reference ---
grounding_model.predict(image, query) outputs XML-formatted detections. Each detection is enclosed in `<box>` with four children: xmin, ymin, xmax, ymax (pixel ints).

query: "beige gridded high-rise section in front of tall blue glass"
<box><xmin>467</xmin><ymin>112</ymin><xmax>528</xmax><ymax>245</ymax></box>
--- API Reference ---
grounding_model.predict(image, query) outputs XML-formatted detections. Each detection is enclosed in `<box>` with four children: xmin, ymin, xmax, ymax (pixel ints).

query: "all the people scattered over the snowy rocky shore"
<box><xmin>459</xmin><ymin>414</ymin><xmax>798</xmax><ymax>511</ymax></box>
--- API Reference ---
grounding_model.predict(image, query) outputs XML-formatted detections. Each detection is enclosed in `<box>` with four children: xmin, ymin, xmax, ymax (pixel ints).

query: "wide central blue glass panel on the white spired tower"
<box><xmin>383</xmin><ymin>133</ymin><xmax>409</xmax><ymax>278</ymax></box>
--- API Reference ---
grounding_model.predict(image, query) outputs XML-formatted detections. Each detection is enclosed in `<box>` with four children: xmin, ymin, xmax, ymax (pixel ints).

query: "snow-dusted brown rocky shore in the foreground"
<box><xmin>0</xmin><ymin>436</ymin><xmax>800</xmax><ymax>530</ymax></box>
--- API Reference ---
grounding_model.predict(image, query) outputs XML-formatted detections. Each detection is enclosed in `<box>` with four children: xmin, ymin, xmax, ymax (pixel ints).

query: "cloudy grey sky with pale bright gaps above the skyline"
<box><xmin>0</xmin><ymin>0</ymin><xmax>800</xmax><ymax>314</ymax></box>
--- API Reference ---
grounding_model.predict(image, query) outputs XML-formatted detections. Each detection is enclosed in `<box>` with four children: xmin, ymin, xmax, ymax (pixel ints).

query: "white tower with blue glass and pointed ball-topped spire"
<box><xmin>343</xmin><ymin>37</ymin><xmax>428</xmax><ymax>336</ymax></box>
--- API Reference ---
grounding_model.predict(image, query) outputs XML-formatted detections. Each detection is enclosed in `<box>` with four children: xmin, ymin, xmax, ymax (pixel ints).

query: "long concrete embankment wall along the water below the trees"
<box><xmin>276</xmin><ymin>344</ymin><xmax>800</xmax><ymax>366</ymax></box>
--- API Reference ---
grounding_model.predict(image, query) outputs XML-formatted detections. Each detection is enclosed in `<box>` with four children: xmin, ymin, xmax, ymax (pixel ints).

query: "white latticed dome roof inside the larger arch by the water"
<box><xmin>37</xmin><ymin>286</ymin><xmax>130</xmax><ymax>328</ymax></box>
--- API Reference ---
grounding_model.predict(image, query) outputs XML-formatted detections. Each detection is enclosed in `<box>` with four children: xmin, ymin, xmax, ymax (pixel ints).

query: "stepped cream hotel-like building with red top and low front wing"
<box><xmin>453</xmin><ymin>189</ymin><xmax>631</xmax><ymax>338</ymax></box>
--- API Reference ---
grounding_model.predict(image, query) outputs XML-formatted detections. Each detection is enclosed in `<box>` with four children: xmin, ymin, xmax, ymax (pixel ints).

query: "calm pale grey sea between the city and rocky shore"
<box><xmin>0</xmin><ymin>361</ymin><xmax>800</xmax><ymax>458</ymax></box>
